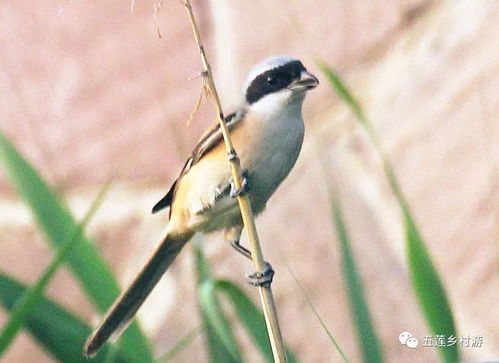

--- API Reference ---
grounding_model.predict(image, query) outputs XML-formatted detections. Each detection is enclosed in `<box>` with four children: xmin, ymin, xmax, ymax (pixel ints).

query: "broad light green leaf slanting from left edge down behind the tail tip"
<box><xmin>0</xmin><ymin>132</ymin><xmax>152</xmax><ymax>362</ymax></box>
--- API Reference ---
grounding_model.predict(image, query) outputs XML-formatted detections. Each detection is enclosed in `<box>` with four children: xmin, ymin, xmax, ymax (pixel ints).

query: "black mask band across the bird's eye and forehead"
<box><xmin>246</xmin><ymin>61</ymin><xmax>305</xmax><ymax>104</ymax></box>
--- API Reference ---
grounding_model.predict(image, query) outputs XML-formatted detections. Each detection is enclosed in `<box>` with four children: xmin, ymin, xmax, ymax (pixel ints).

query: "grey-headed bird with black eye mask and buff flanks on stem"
<box><xmin>84</xmin><ymin>56</ymin><xmax>319</xmax><ymax>357</ymax></box>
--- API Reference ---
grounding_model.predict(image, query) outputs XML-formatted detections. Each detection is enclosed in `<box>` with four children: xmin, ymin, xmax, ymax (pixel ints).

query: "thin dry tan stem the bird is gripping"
<box><xmin>182</xmin><ymin>0</ymin><xmax>287</xmax><ymax>363</ymax></box>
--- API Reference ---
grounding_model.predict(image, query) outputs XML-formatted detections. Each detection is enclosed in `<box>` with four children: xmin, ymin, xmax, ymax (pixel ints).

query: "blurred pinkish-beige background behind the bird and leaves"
<box><xmin>0</xmin><ymin>0</ymin><xmax>499</xmax><ymax>362</ymax></box>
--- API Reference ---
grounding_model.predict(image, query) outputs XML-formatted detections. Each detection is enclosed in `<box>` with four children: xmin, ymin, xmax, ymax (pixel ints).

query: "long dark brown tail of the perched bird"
<box><xmin>84</xmin><ymin>232</ymin><xmax>192</xmax><ymax>357</ymax></box>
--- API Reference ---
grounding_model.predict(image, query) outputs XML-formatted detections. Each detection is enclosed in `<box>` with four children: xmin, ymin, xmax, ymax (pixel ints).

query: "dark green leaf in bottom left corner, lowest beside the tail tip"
<box><xmin>0</xmin><ymin>273</ymin><xmax>125</xmax><ymax>363</ymax></box>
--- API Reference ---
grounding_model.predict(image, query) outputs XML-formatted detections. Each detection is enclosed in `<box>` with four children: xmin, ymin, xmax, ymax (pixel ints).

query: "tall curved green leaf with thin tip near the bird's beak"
<box><xmin>320</xmin><ymin>62</ymin><xmax>459</xmax><ymax>362</ymax></box>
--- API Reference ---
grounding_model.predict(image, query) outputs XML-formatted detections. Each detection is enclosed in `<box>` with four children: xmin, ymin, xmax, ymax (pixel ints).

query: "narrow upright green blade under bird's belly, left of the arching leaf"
<box><xmin>193</xmin><ymin>239</ymin><xmax>242</xmax><ymax>363</ymax></box>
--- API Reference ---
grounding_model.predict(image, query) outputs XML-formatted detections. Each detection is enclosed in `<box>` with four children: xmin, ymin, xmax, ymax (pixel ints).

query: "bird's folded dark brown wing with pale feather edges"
<box><xmin>152</xmin><ymin>112</ymin><xmax>244</xmax><ymax>214</ymax></box>
